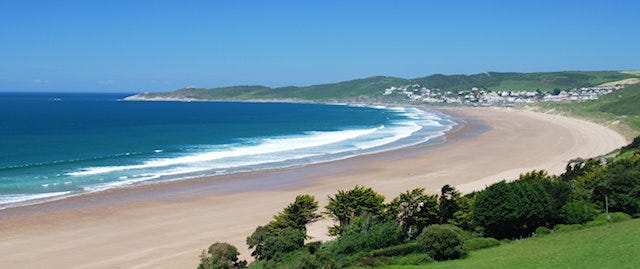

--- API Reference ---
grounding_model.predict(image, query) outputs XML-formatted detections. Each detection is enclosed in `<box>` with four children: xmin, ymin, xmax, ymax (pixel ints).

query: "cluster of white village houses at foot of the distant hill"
<box><xmin>382</xmin><ymin>84</ymin><xmax>626</xmax><ymax>106</ymax></box>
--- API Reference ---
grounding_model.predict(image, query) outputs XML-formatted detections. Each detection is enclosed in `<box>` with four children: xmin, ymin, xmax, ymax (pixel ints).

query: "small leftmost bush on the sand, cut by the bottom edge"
<box><xmin>198</xmin><ymin>242</ymin><xmax>247</xmax><ymax>269</ymax></box>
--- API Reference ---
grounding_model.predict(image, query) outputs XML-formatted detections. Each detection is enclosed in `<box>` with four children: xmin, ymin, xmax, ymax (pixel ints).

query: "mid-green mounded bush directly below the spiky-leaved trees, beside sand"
<box><xmin>333</xmin><ymin>214</ymin><xmax>403</xmax><ymax>254</ymax></box>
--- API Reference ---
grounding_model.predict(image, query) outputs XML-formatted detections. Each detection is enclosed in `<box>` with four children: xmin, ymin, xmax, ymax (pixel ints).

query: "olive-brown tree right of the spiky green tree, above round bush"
<box><xmin>386</xmin><ymin>188</ymin><xmax>438</xmax><ymax>238</ymax></box>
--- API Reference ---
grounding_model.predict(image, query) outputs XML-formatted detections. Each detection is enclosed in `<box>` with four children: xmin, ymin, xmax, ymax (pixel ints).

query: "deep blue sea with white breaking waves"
<box><xmin>0</xmin><ymin>93</ymin><xmax>456</xmax><ymax>209</ymax></box>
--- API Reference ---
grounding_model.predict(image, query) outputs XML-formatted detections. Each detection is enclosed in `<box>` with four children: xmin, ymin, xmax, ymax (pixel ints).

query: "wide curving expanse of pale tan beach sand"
<box><xmin>0</xmin><ymin>108</ymin><xmax>626</xmax><ymax>268</ymax></box>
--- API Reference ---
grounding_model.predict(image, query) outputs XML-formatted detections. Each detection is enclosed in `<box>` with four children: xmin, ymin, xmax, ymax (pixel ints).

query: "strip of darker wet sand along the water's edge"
<box><xmin>0</xmin><ymin>103</ymin><xmax>470</xmax><ymax>218</ymax></box>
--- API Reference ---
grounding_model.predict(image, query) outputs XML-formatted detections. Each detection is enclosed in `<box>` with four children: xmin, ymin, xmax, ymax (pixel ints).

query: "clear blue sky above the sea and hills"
<box><xmin>0</xmin><ymin>0</ymin><xmax>640</xmax><ymax>92</ymax></box>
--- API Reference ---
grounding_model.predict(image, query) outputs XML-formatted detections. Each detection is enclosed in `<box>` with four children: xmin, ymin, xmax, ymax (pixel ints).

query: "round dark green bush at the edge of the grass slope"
<box><xmin>416</xmin><ymin>224</ymin><xmax>467</xmax><ymax>261</ymax></box>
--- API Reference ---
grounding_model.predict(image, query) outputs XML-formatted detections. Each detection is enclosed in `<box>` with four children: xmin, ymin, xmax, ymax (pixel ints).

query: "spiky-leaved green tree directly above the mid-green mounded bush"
<box><xmin>325</xmin><ymin>186</ymin><xmax>384</xmax><ymax>235</ymax></box>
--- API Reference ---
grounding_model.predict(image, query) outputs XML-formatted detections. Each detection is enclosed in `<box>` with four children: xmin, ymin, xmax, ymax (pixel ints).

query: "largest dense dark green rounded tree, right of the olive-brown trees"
<box><xmin>473</xmin><ymin>180</ymin><xmax>551</xmax><ymax>238</ymax></box>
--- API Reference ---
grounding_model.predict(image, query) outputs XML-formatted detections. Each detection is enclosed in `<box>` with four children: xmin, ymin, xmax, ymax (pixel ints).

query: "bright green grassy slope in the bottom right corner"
<box><xmin>372</xmin><ymin>219</ymin><xmax>640</xmax><ymax>269</ymax></box>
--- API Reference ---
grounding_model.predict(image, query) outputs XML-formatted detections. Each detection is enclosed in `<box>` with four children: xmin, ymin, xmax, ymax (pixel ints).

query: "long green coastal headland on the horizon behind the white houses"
<box><xmin>126</xmin><ymin>71</ymin><xmax>640</xmax><ymax>101</ymax></box>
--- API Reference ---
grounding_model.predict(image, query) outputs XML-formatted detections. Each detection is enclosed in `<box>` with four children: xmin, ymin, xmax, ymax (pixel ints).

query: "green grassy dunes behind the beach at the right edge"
<box><xmin>538</xmin><ymin>84</ymin><xmax>640</xmax><ymax>139</ymax></box>
